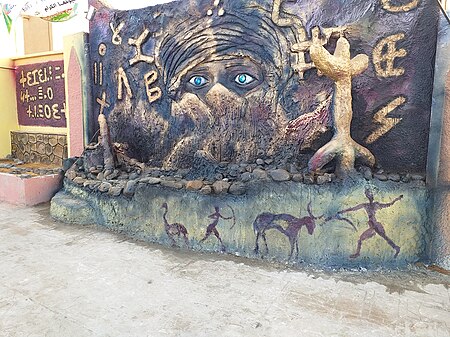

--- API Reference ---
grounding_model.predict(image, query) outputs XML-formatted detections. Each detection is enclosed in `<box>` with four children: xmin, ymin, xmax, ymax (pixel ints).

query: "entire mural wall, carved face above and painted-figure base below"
<box><xmin>52</xmin><ymin>0</ymin><xmax>438</xmax><ymax>267</ymax></box>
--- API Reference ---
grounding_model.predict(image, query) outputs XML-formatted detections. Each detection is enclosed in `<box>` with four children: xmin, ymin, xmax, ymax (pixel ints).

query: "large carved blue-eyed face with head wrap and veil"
<box><xmin>156</xmin><ymin>10</ymin><xmax>289</xmax><ymax>167</ymax></box>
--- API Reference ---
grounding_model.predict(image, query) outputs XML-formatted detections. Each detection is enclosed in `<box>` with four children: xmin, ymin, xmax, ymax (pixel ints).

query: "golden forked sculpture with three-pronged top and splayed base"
<box><xmin>308</xmin><ymin>36</ymin><xmax>375</xmax><ymax>178</ymax></box>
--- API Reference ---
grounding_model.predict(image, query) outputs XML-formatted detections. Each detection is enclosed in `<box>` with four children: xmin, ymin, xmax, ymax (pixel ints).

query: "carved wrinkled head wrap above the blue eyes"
<box><xmin>156</xmin><ymin>1</ymin><xmax>295</xmax><ymax>85</ymax></box>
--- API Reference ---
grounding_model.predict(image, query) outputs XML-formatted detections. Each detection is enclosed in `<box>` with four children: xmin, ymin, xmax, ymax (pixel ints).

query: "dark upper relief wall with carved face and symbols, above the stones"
<box><xmin>90</xmin><ymin>0</ymin><xmax>437</xmax><ymax>176</ymax></box>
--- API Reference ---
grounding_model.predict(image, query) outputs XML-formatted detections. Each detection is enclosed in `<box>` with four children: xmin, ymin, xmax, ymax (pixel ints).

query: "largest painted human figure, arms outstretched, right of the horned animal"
<box><xmin>337</xmin><ymin>189</ymin><xmax>403</xmax><ymax>258</ymax></box>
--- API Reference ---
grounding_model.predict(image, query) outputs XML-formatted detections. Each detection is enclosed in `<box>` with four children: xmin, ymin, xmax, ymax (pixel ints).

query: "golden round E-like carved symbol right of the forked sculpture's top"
<box><xmin>373</xmin><ymin>33</ymin><xmax>408</xmax><ymax>77</ymax></box>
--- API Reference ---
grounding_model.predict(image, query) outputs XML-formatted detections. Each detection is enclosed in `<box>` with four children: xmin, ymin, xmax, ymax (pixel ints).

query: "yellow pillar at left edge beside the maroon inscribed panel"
<box><xmin>0</xmin><ymin>59</ymin><xmax>18</xmax><ymax>158</ymax></box>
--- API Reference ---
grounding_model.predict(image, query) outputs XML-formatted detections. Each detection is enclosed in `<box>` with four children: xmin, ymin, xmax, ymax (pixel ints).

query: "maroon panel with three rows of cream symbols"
<box><xmin>16</xmin><ymin>60</ymin><xmax>66</xmax><ymax>127</ymax></box>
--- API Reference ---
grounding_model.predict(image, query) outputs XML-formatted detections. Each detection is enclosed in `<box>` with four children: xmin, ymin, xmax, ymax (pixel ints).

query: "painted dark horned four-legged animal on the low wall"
<box><xmin>253</xmin><ymin>203</ymin><xmax>323</xmax><ymax>259</ymax></box>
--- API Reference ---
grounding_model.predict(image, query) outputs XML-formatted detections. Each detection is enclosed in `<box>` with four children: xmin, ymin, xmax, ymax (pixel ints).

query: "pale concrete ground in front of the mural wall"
<box><xmin>0</xmin><ymin>203</ymin><xmax>450</xmax><ymax>337</ymax></box>
